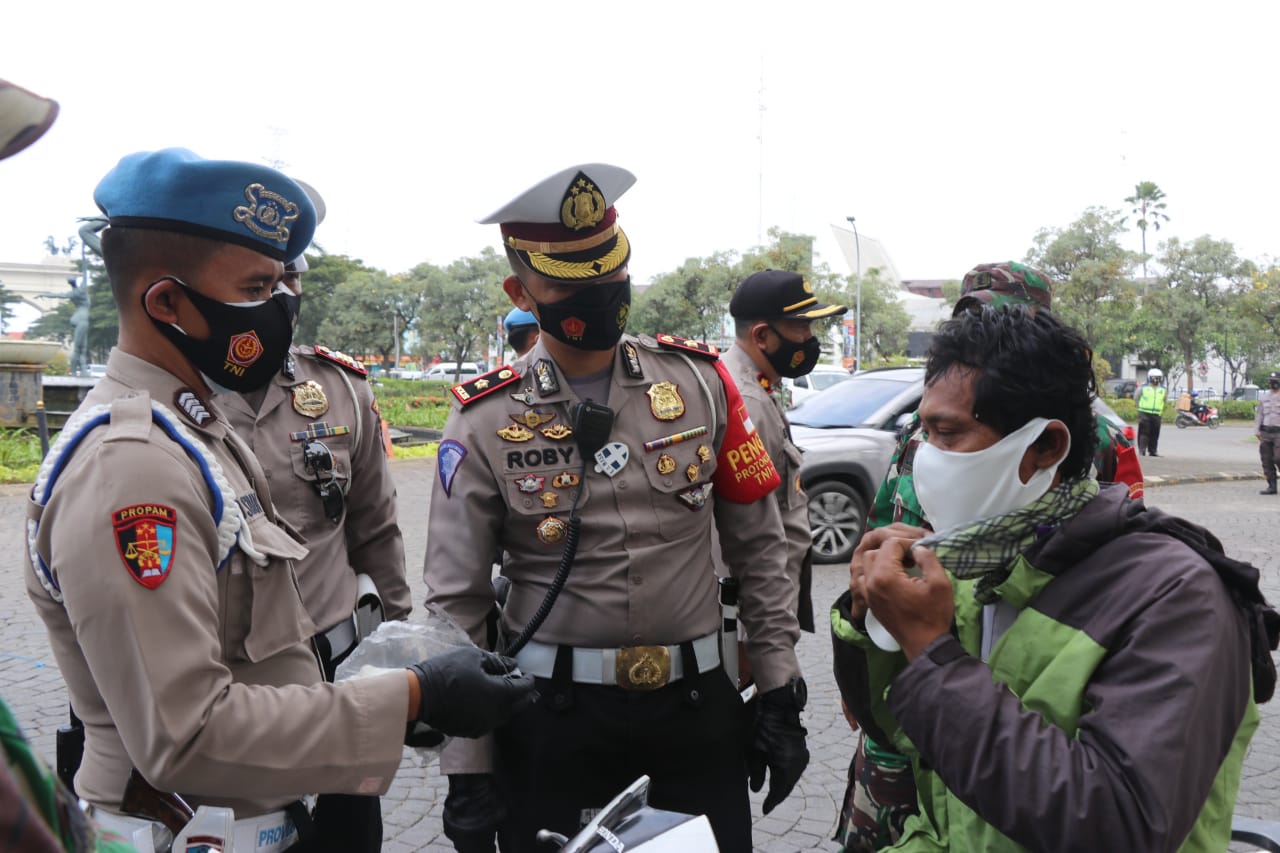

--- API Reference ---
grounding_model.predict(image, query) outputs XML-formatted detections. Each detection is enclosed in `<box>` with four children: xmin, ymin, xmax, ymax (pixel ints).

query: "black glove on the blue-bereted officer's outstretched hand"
<box><xmin>408</xmin><ymin>646</ymin><xmax>538</xmax><ymax>738</ymax></box>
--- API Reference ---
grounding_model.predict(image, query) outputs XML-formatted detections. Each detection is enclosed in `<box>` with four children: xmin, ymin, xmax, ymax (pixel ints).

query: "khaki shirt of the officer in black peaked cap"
<box><xmin>722</xmin><ymin>343</ymin><xmax>813</xmax><ymax>612</ymax></box>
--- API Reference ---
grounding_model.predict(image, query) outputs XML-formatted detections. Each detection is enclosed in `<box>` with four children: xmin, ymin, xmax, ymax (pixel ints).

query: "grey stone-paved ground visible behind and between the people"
<box><xmin>0</xmin><ymin>427</ymin><xmax>1280</xmax><ymax>853</ymax></box>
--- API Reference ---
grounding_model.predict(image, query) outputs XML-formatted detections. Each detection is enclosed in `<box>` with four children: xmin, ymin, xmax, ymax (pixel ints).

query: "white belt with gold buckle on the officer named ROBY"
<box><xmin>516</xmin><ymin>633</ymin><xmax>719</xmax><ymax>690</ymax></box>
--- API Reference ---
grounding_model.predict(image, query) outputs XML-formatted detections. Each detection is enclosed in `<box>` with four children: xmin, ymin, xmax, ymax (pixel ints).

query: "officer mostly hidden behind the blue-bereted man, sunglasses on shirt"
<box><xmin>214</xmin><ymin>181</ymin><xmax>412</xmax><ymax>849</ymax></box>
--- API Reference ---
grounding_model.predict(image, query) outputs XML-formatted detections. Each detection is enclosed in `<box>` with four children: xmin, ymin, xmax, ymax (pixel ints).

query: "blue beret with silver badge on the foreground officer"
<box><xmin>93</xmin><ymin>149</ymin><xmax>316</xmax><ymax>260</ymax></box>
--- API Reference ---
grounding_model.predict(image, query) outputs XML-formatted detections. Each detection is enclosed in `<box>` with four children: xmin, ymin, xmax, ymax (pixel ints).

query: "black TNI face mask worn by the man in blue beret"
<box><xmin>142</xmin><ymin>277</ymin><xmax>296</xmax><ymax>393</ymax></box>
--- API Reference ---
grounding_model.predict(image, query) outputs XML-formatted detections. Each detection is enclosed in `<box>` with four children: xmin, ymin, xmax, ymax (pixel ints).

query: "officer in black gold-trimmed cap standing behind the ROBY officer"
<box><xmin>724</xmin><ymin>269</ymin><xmax>849</xmax><ymax>633</ymax></box>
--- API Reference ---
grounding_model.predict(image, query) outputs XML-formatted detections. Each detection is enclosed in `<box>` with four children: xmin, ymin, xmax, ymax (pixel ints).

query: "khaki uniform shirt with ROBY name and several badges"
<box><xmin>424</xmin><ymin>336</ymin><xmax>799</xmax><ymax>774</ymax></box>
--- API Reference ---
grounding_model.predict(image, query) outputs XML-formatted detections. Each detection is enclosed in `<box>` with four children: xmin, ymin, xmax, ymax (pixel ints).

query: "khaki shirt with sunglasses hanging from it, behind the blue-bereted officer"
<box><xmin>214</xmin><ymin>346</ymin><xmax>412</xmax><ymax>630</ymax></box>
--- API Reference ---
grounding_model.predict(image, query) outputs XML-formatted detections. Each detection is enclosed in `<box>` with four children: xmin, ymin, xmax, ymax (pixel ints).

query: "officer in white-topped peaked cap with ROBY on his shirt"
<box><xmin>425</xmin><ymin>164</ymin><xmax>808</xmax><ymax>850</ymax></box>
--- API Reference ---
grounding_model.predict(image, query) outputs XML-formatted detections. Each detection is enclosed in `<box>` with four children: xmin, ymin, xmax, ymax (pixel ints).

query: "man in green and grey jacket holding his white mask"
<box><xmin>833</xmin><ymin>306</ymin><xmax>1280</xmax><ymax>850</ymax></box>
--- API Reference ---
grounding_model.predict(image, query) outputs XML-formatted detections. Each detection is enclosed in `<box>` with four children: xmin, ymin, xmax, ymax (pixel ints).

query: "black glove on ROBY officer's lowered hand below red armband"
<box><xmin>746</xmin><ymin>679</ymin><xmax>809</xmax><ymax>815</ymax></box>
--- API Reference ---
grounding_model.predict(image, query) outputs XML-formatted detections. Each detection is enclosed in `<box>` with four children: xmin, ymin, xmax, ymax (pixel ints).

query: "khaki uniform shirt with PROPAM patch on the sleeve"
<box><xmin>26</xmin><ymin>350</ymin><xmax>408</xmax><ymax>817</ymax></box>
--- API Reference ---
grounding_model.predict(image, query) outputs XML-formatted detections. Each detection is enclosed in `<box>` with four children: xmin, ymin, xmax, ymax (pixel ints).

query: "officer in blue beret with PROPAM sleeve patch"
<box><xmin>24</xmin><ymin>149</ymin><xmax>531</xmax><ymax>850</ymax></box>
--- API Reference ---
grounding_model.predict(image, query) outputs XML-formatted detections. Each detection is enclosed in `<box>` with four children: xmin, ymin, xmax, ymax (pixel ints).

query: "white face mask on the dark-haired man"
<box><xmin>911</xmin><ymin>418</ymin><xmax>1071</xmax><ymax>533</ymax></box>
